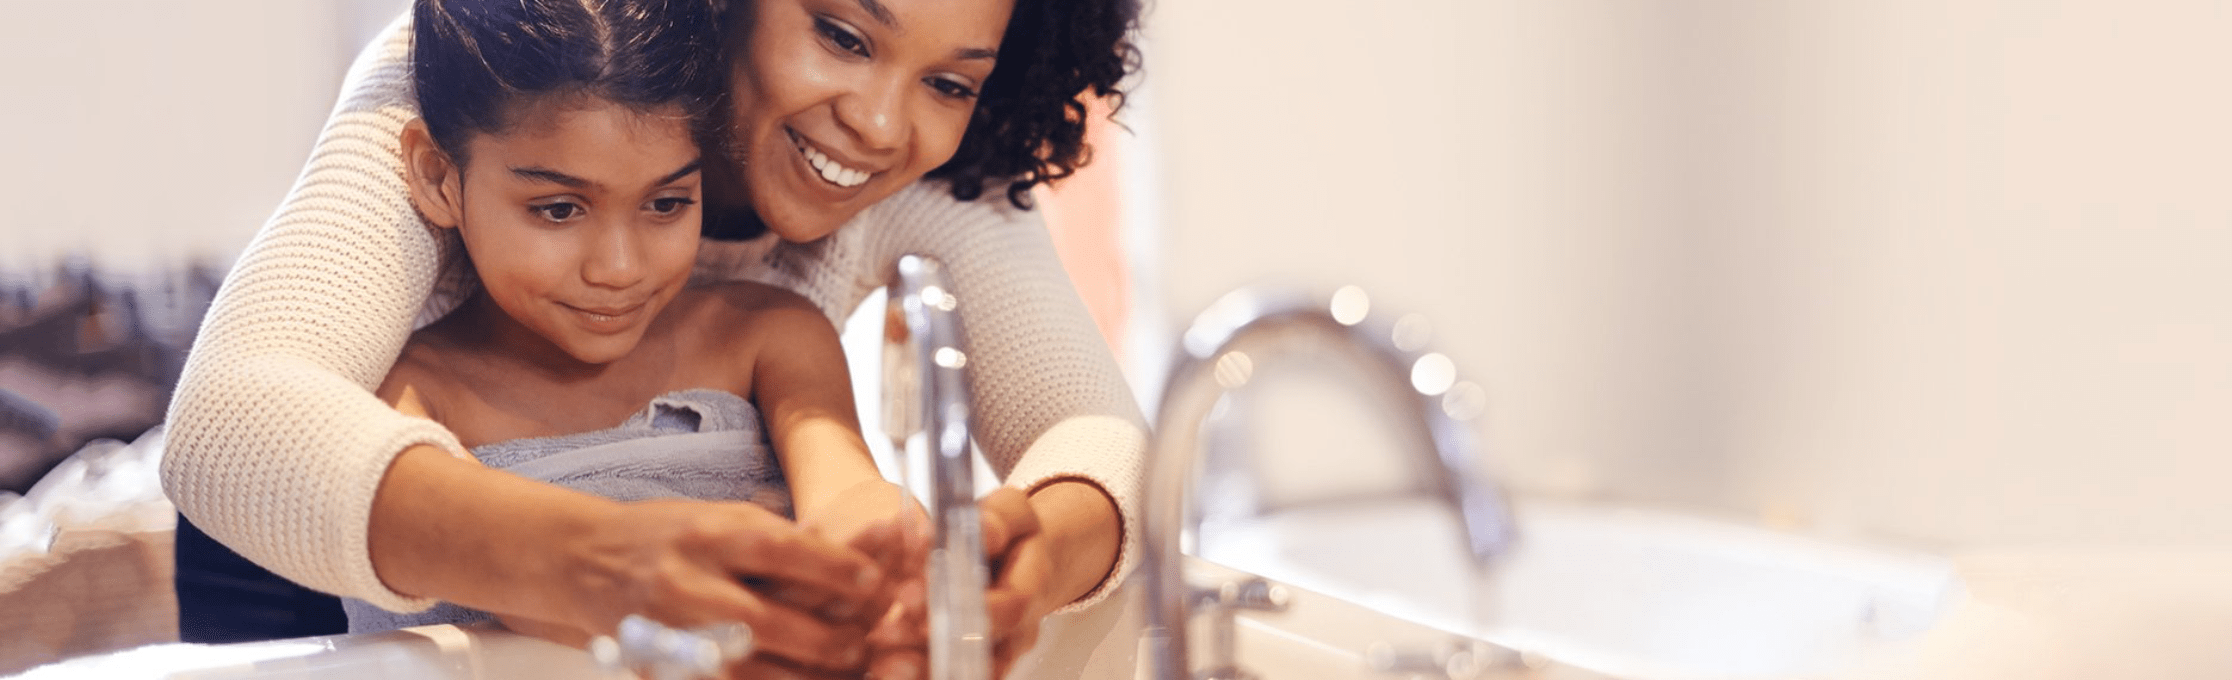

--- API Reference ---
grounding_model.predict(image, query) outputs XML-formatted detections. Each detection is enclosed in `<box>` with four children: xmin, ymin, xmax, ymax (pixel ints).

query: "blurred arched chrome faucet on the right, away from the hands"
<box><xmin>1141</xmin><ymin>288</ymin><xmax>1518</xmax><ymax>680</ymax></box>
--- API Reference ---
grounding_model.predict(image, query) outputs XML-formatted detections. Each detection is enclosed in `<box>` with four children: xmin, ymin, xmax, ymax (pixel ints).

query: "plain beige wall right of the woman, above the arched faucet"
<box><xmin>1141</xmin><ymin>0</ymin><xmax>2232</xmax><ymax>544</ymax></box>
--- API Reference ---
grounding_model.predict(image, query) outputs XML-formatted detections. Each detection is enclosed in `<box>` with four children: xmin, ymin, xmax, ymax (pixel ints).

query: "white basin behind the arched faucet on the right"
<box><xmin>1199</xmin><ymin>499</ymin><xmax>1960</xmax><ymax>680</ymax></box>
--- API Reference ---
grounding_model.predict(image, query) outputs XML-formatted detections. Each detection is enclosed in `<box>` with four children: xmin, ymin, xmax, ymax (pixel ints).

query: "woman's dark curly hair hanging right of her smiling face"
<box><xmin>931</xmin><ymin>0</ymin><xmax>1141</xmax><ymax>207</ymax></box>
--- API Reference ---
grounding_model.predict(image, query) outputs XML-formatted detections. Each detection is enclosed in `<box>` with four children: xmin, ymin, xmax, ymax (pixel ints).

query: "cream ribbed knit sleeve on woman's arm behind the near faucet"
<box><xmin>701</xmin><ymin>181</ymin><xmax>1147</xmax><ymax>609</ymax></box>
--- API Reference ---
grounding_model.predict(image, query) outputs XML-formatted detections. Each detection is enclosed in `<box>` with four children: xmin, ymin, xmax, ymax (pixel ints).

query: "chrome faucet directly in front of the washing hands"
<box><xmin>884</xmin><ymin>254</ymin><xmax>991</xmax><ymax>680</ymax></box>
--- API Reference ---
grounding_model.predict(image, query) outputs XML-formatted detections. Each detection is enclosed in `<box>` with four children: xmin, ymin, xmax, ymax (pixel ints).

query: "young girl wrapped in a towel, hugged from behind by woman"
<box><xmin>346</xmin><ymin>0</ymin><xmax>899</xmax><ymax>642</ymax></box>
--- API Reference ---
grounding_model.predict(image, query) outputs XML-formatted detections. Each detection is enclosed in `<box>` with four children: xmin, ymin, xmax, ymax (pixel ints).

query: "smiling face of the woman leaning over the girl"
<box><xmin>728</xmin><ymin>0</ymin><xmax>1016</xmax><ymax>241</ymax></box>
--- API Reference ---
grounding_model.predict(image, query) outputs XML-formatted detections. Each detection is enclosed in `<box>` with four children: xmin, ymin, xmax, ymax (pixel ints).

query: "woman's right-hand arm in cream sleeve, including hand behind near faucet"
<box><xmin>785</xmin><ymin>183</ymin><xmax>1145</xmax><ymax>671</ymax></box>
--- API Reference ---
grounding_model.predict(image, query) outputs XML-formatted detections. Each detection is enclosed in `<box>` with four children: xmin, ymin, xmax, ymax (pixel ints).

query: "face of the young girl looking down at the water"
<box><xmin>419</xmin><ymin>98</ymin><xmax>699</xmax><ymax>363</ymax></box>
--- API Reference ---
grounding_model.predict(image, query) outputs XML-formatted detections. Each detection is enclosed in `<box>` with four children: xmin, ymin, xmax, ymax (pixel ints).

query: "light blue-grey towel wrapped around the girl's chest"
<box><xmin>341</xmin><ymin>390</ymin><xmax>790</xmax><ymax>633</ymax></box>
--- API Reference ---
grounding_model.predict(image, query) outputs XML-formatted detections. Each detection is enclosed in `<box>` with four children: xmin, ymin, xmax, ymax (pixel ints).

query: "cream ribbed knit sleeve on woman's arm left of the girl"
<box><xmin>163</xmin><ymin>14</ymin><xmax>462</xmax><ymax>611</ymax></box>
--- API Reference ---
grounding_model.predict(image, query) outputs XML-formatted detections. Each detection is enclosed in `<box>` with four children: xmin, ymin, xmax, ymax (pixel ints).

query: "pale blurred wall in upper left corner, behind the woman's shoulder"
<box><xmin>0</xmin><ymin>0</ymin><xmax>404</xmax><ymax>272</ymax></box>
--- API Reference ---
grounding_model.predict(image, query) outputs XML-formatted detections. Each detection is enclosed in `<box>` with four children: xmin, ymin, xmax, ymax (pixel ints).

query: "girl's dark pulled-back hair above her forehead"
<box><xmin>411</xmin><ymin>0</ymin><xmax>725</xmax><ymax>163</ymax></box>
